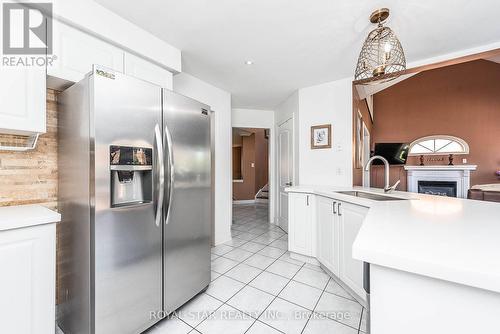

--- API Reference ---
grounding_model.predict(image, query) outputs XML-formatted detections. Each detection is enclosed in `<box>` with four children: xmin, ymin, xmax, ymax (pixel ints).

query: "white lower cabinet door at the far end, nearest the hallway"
<box><xmin>288</xmin><ymin>193</ymin><xmax>316</xmax><ymax>256</ymax></box>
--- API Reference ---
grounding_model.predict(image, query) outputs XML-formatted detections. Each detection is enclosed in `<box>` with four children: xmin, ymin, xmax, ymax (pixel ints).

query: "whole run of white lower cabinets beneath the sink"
<box><xmin>288</xmin><ymin>192</ymin><xmax>368</xmax><ymax>299</ymax></box>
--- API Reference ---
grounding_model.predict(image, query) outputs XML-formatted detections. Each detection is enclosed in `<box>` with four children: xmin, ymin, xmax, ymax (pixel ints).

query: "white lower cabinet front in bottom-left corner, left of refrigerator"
<box><xmin>0</xmin><ymin>224</ymin><xmax>56</xmax><ymax>334</ymax></box>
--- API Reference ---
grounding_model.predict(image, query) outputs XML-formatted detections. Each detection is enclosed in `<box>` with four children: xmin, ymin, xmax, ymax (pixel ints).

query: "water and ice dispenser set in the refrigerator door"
<box><xmin>109</xmin><ymin>146</ymin><xmax>153</xmax><ymax>207</ymax></box>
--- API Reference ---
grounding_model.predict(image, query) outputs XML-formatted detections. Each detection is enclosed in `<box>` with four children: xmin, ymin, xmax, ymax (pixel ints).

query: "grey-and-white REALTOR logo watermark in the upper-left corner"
<box><xmin>2</xmin><ymin>2</ymin><xmax>56</xmax><ymax>67</ymax></box>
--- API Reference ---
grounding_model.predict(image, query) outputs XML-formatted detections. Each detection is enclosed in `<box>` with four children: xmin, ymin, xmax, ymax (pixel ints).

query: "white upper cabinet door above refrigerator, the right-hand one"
<box><xmin>125</xmin><ymin>53</ymin><xmax>172</xmax><ymax>90</ymax></box>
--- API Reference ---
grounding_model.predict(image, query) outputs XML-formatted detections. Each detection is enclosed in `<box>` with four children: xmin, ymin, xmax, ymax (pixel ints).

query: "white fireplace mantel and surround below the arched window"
<box><xmin>404</xmin><ymin>165</ymin><xmax>477</xmax><ymax>198</ymax></box>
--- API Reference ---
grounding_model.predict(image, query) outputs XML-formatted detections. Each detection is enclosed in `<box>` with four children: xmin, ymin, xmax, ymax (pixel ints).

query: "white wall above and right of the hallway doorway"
<box><xmin>231</xmin><ymin>109</ymin><xmax>277</xmax><ymax>224</ymax></box>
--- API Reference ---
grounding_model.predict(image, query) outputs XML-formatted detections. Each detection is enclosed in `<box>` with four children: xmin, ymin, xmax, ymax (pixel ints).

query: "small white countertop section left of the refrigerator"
<box><xmin>0</xmin><ymin>205</ymin><xmax>61</xmax><ymax>231</ymax></box>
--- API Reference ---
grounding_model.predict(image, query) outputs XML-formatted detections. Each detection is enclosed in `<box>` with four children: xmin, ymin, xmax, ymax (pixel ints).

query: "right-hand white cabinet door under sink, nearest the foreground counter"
<box><xmin>337</xmin><ymin>202</ymin><xmax>368</xmax><ymax>296</ymax></box>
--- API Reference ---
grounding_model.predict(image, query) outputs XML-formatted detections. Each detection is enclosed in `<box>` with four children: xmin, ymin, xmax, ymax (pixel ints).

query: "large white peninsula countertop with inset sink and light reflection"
<box><xmin>287</xmin><ymin>186</ymin><xmax>500</xmax><ymax>292</ymax></box>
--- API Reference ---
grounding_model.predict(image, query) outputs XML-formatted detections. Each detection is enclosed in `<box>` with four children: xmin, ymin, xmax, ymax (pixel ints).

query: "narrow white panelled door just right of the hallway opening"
<box><xmin>278</xmin><ymin>118</ymin><xmax>293</xmax><ymax>232</ymax></box>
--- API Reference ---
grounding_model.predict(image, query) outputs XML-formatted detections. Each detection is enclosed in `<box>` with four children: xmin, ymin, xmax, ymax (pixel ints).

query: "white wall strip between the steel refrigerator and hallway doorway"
<box><xmin>174</xmin><ymin>73</ymin><xmax>232</xmax><ymax>245</ymax></box>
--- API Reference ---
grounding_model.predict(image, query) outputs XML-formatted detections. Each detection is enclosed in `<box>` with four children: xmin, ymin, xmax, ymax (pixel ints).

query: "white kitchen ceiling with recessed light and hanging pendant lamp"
<box><xmin>96</xmin><ymin>0</ymin><xmax>500</xmax><ymax>109</ymax></box>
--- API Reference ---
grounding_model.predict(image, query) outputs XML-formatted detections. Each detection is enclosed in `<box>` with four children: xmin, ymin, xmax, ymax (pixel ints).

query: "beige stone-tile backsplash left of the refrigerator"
<box><xmin>0</xmin><ymin>89</ymin><xmax>58</xmax><ymax>209</ymax></box>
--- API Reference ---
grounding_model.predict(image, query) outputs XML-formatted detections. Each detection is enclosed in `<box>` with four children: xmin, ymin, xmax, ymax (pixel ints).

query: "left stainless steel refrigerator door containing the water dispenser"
<box><xmin>91</xmin><ymin>69</ymin><xmax>164</xmax><ymax>334</ymax></box>
